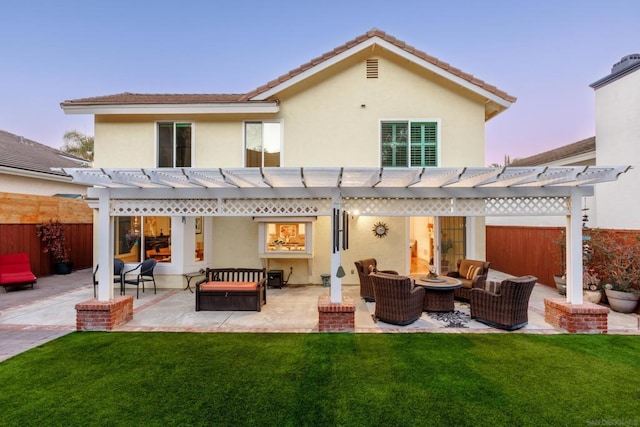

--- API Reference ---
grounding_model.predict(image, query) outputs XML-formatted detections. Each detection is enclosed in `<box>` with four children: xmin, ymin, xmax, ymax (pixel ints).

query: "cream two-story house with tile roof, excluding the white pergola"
<box><xmin>62</xmin><ymin>30</ymin><xmax>515</xmax><ymax>292</ymax></box>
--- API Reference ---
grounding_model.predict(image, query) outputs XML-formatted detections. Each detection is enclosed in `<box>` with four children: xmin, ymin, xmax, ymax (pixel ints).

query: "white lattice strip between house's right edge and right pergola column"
<box><xmin>485</xmin><ymin>197</ymin><xmax>571</xmax><ymax>216</ymax></box>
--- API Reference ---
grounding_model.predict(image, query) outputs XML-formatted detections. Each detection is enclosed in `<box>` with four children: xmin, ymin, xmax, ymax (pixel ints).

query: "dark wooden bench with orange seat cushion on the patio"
<box><xmin>196</xmin><ymin>268</ymin><xmax>267</xmax><ymax>311</ymax></box>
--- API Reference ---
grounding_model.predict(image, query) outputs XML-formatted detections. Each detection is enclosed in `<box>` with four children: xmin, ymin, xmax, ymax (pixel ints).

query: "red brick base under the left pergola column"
<box><xmin>76</xmin><ymin>296</ymin><xmax>133</xmax><ymax>331</ymax></box>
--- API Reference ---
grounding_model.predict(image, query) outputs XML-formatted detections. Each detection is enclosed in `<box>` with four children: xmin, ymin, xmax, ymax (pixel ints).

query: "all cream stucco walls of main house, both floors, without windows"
<box><xmin>87</xmin><ymin>50</ymin><xmax>492</xmax><ymax>287</ymax></box>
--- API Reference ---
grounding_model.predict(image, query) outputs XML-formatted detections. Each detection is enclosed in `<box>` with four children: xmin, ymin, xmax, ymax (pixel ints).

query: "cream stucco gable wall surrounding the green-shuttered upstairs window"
<box><xmin>280</xmin><ymin>56</ymin><xmax>484</xmax><ymax>166</ymax></box>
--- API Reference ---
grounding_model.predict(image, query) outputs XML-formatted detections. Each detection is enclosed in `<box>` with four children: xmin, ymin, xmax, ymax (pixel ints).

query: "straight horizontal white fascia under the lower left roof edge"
<box><xmin>62</xmin><ymin>102</ymin><xmax>280</xmax><ymax>115</ymax></box>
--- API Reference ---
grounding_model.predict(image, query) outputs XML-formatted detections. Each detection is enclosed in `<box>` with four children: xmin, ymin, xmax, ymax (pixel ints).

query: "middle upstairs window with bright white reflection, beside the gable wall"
<box><xmin>244</xmin><ymin>122</ymin><xmax>281</xmax><ymax>167</ymax></box>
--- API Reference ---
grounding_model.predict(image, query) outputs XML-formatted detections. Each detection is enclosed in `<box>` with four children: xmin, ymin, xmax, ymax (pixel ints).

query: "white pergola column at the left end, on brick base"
<box><xmin>94</xmin><ymin>188</ymin><xmax>114</xmax><ymax>301</ymax></box>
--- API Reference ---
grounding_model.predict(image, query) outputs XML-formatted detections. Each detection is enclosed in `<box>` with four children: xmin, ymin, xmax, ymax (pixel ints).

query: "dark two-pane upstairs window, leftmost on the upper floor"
<box><xmin>158</xmin><ymin>122</ymin><xmax>193</xmax><ymax>168</ymax></box>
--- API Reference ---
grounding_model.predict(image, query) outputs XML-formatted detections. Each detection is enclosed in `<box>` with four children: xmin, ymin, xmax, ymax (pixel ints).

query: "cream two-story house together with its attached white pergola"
<box><xmin>62</xmin><ymin>30</ymin><xmax>617</xmax><ymax>314</ymax></box>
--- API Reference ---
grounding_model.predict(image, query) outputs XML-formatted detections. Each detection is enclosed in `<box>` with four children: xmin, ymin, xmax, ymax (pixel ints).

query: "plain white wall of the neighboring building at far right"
<box><xmin>595</xmin><ymin>70</ymin><xmax>640</xmax><ymax>229</ymax></box>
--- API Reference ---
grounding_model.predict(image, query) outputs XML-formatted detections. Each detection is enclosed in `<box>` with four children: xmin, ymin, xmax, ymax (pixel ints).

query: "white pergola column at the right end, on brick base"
<box><xmin>566</xmin><ymin>190</ymin><xmax>583</xmax><ymax>304</ymax></box>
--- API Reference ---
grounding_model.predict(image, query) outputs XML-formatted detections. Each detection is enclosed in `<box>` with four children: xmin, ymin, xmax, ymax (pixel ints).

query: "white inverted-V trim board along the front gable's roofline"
<box><xmin>251</xmin><ymin>36</ymin><xmax>512</xmax><ymax>108</ymax></box>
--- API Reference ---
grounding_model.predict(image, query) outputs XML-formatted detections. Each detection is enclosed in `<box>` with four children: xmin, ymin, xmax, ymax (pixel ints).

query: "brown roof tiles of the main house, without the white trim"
<box><xmin>60</xmin><ymin>29</ymin><xmax>517</xmax><ymax>107</ymax></box>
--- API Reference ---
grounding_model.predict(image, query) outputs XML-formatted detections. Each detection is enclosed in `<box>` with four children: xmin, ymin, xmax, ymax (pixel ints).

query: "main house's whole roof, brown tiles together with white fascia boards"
<box><xmin>60</xmin><ymin>29</ymin><xmax>516</xmax><ymax>120</ymax></box>
